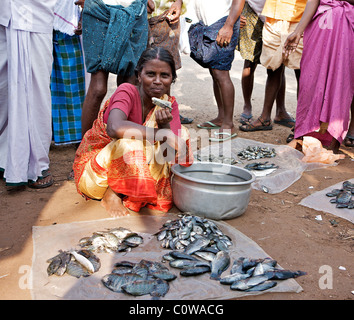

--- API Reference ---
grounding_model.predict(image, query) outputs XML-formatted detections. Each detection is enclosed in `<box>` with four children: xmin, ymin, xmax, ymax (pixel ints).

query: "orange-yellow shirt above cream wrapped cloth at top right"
<box><xmin>262</xmin><ymin>0</ymin><xmax>307</xmax><ymax>22</ymax></box>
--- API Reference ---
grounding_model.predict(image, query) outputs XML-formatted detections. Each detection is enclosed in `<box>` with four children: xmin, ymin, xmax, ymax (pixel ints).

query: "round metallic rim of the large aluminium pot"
<box><xmin>171</xmin><ymin>161</ymin><xmax>256</xmax><ymax>186</ymax></box>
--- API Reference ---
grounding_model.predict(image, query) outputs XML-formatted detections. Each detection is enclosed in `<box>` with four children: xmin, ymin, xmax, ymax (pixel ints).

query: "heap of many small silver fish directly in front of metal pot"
<box><xmin>154</xmin><ymin>214</ymin><xmax>232</xmax><ymax>254</ymax></box>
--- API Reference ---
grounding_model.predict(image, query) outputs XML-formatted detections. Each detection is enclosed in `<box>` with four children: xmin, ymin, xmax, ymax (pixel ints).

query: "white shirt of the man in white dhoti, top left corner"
<box><xmin>0</xmin><ymin>0</ymin><xmax>56</xmax><ymax>33</ymax></box>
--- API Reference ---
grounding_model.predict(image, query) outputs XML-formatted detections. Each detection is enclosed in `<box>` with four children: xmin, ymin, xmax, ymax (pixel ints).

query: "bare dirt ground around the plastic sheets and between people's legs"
<box><xmin>0</xmin><ymin>56</ymin><xmax>354</xmax><ymax>300</ymax></box>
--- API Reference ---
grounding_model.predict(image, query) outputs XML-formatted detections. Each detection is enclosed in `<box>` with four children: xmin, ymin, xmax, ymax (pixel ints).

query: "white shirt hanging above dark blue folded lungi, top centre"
<box><xmin>194</xmin><ymin>0</ymin><xmax>232</xmax><ymax>26</ymax></box>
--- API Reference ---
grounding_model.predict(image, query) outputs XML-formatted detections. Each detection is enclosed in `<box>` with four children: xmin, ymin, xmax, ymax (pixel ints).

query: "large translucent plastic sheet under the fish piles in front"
<box><xmin>31</xmin><ymin>214</ymin><xmax>306</xmax><ymax>300</ymax></box>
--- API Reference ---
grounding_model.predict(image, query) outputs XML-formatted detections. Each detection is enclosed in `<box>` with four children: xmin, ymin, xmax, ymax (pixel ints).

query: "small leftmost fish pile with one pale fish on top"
<box><xmin>47</xmin><ymin>250</ymin><xmax>101</xmax><ymax>278</ymax></box>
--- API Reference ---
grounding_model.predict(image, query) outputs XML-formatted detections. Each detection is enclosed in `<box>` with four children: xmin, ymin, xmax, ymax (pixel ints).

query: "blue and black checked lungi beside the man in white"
<box><xmin>50</xmin><ymin>31</ymin><xmax>85</xmax><ymax>144</ymax></box>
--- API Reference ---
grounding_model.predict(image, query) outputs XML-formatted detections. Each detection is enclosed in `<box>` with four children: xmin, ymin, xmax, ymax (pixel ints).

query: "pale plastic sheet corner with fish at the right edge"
<box><xmin>300</xmin><ymin>179</ymin><xmax>354</xmax><ymax>223</ymax></box>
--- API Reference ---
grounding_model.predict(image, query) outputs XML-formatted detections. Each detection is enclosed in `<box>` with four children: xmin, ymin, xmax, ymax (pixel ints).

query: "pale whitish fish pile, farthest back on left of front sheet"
<box><xmin>79</xmin><ymin>227</ymin><xmax>143</xmax><ymax>253</ymax></box>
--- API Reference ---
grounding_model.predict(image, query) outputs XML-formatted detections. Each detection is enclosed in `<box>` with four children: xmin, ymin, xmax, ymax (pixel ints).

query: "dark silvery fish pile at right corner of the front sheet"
<box><xmin>220</xmin><ymin>257</ymin><xmax>306</xmax><ymax>292</ymax></box>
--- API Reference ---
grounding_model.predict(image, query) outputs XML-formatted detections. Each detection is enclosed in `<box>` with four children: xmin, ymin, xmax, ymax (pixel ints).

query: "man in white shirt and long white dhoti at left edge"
<box><xmin>0</xmin><ymin>0</ymin><xmax>57</xmax><ymax>188</ymax></box>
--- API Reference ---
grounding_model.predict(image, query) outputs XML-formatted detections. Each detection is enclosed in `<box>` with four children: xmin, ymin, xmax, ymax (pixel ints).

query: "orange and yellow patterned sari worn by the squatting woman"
<box><xmin>74</xmin><ymin>97</ymin><xmax>193</xmax><ymax>212</ymax></box>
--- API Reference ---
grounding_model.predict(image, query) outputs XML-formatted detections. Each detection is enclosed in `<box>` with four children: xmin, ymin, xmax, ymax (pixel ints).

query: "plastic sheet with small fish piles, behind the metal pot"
<box><xmin>194</xmin><ymin>138</ymin><xmax>337</xmax><ymax>194</ymax></box>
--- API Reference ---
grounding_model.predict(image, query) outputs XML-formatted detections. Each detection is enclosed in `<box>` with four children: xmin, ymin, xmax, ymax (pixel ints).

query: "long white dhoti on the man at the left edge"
<box><xmin>0</xmin><ymin>23</ymin><xmax>53</xmax><ymax>184</ymax></box>
